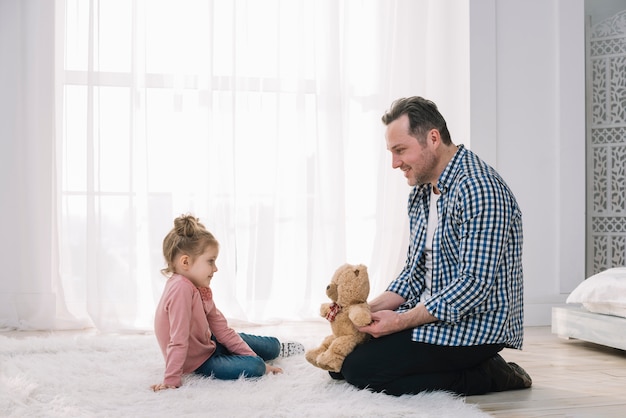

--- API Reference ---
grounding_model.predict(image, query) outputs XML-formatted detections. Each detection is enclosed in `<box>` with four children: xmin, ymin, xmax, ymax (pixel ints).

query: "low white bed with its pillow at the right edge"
<box><xmin>552</xmin><ymin>267</ymin><xmax>626</xmax><ymax>350</ymax></box>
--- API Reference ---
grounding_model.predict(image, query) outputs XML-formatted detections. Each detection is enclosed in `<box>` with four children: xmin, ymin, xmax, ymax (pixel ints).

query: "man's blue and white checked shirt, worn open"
<box><xmin>387</xmin><ymin>145</ymin><xmax>524</xmax><ymax>349</ymax></box>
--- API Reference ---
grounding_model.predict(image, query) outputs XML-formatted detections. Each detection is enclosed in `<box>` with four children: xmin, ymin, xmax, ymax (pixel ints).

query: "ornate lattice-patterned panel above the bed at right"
<box><xmin>587</xmin><ymin>11</ymin><xmax>626</xmax><ymax>273</ymax></box>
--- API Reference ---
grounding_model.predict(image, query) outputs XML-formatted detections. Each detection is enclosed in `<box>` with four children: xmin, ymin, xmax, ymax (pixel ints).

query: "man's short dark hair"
<box><xmin>382</xmin><ymin>96</ymin><xmax>452</xmax><ymax>145</ymax></box>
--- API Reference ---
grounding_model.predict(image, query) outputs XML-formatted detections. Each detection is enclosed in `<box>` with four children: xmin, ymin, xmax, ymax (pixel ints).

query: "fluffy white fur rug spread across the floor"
<box><xmin>0</xmin><ymin>331</ymin><xmax>488</xmax><ymax>418</ymax></box>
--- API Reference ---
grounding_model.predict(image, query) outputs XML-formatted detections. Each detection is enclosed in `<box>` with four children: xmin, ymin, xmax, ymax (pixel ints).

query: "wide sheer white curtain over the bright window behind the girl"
<box><xmin>0</xmin><ymin>0</ymin><xmax>458</xmax><ymax>330</ymax></box>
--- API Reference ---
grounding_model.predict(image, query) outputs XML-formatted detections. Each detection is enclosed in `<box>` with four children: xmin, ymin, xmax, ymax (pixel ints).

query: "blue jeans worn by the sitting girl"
<box><xmin>194</xmin><ymin>332</ymin><xmax>280</xmax><ymax>380</ymax></box>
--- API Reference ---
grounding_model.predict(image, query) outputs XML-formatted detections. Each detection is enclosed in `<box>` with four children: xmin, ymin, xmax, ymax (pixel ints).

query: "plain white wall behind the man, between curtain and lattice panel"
<box><xmin>470</xmin><ymin>0</ymin><xmax>585</xmax><ymax>326</ymax></box>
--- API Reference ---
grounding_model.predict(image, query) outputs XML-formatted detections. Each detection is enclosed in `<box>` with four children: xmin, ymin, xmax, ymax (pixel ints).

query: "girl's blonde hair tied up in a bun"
<box><xmin>161</xmin><ymin>215</ymin><xmax>219</xmax><ymax>277</ymax></box>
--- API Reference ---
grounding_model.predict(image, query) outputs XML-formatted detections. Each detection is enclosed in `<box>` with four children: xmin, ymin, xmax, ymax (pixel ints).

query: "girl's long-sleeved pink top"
<box><xmin>154</xmin><ymin>274</ymin><xmax>257</xmax><ymax>387</ymax></box>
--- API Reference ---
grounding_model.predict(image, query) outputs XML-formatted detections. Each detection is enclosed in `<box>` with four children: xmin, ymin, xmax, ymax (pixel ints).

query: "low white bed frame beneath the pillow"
<box><xmin>552</xmin><ymin>305</ymin><xmax>626</xmax><ymax>350</ymax></box>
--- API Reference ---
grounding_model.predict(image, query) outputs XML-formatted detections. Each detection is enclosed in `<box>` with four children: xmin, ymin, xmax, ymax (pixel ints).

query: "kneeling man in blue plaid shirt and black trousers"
<box><xmin>331</xmin><ymin>97</ymin><xmax>532</xmax><ymax>395</ymax></box>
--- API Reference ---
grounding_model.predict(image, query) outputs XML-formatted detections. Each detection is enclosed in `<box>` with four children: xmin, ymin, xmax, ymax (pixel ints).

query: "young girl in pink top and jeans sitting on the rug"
<box><xmin>151</xmin><ymin>215</ymin><xmax>304</xmax><ymax>392</ymax></box>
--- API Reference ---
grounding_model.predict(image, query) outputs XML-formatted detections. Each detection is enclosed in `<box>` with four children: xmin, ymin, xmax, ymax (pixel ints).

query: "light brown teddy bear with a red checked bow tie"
<box><xmin>305</xmin><ymin>264</ymin><xmax>372</xmax><ymax>372</ymax></box>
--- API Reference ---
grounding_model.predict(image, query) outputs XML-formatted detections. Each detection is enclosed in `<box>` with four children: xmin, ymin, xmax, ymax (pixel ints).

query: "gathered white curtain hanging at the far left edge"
<box><xmin>0</xmin><ymin>0</ymin><xmax>80</xmax><ymax>330</ymax></box>
